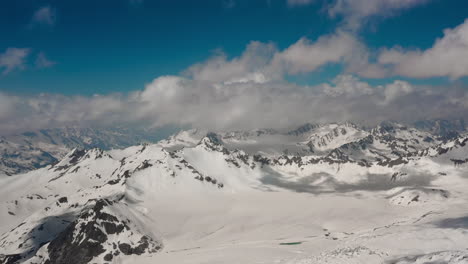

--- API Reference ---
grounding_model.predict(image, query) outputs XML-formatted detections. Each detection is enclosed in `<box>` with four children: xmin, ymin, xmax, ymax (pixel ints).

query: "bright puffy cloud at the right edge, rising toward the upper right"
<box><xmin>378</xmin><ymin>19</ymin><xmax>468</xmax><ymax>79</ymax></box>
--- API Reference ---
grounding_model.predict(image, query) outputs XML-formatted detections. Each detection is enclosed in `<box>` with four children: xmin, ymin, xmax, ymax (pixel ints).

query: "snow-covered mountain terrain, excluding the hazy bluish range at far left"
<box><xmin>0</xmin><ymin>124</ymin><xmax>468</xmax><ymax>264</ymax></box>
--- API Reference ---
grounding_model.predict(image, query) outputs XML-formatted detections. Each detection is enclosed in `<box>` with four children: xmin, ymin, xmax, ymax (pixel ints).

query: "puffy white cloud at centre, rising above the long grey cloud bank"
<box><xmin>183</xmin><ymin>30</ymin><xmax>372</xmax><ymax>79</ymax></box>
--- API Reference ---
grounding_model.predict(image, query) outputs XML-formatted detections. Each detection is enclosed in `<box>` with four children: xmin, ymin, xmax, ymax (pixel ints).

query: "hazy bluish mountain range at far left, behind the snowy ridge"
<box><xmin>0</xmin><ymin>127</ymin><xmax>172</xmax><ymax>175</ymax></box>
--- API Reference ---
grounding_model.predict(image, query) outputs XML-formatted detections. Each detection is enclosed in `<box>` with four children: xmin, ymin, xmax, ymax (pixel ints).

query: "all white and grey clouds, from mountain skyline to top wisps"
<box><xmin>0</xmin><ymin>0</ymin><xmax>468</xmax><ymax>134</ymax></box>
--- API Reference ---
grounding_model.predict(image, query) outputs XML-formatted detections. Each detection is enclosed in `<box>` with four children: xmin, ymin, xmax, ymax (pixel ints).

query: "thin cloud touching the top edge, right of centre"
<box><xmin>328</xmin><ymin>0</ymin><xmax>429</xmax><ymax>29</ymax></box>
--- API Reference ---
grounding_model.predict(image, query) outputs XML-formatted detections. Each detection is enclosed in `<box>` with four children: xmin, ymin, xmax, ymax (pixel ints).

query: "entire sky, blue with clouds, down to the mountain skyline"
<box><xmin>0</xmin><ymin>0</ymin><xmax>468</xmax><ymax>134</ymax></box>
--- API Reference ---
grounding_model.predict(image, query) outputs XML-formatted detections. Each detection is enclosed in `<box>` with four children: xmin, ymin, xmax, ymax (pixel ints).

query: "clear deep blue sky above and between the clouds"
<box><xmin>0</xmin><ymin>0</ymin><xmax>468</xmax><ymax>95</ymax></box>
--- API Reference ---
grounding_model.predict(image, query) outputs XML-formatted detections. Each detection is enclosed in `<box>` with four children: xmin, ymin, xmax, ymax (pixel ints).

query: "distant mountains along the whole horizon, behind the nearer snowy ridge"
<box><xmin>0</xmin><ymin>120</ymin><xmax>466</xmax><ymax>175</ymax></box>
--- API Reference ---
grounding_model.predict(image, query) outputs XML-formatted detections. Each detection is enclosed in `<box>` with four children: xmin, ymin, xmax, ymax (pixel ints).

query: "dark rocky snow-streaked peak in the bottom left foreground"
<box><xmin>43</xmin><ymin>199</ymin><xmax>162</xmax><ymax>264</ymax></box>
